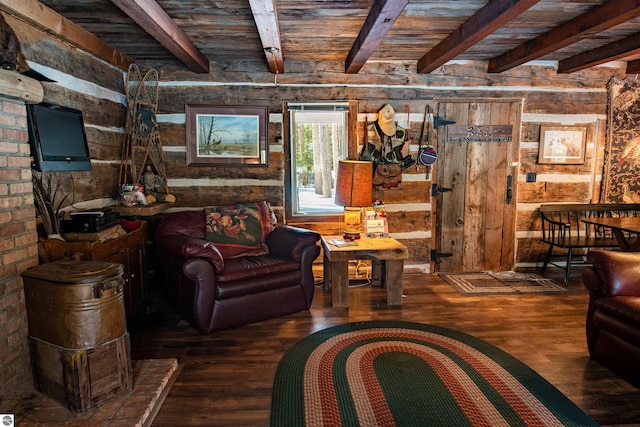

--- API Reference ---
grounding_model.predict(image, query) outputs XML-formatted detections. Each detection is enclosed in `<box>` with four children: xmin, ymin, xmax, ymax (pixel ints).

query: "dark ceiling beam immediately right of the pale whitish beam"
<box><xmin>344</xmin><ymin>0</ymin><xmax>409</xmax><ymax>74</ymax></box>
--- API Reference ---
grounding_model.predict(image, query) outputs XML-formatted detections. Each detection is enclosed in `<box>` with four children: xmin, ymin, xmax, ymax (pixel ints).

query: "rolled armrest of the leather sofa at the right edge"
<box><xmin>585</xmin><ymin>250</ymin><xmax>640</xmax><ymax>296</ymax></box>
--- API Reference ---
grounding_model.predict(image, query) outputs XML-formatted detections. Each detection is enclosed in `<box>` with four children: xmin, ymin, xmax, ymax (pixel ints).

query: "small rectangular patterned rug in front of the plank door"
<box><xmin>438</xmin><ymin>271</ymin><xmax>574</xmax><ymax>295</ymax></box>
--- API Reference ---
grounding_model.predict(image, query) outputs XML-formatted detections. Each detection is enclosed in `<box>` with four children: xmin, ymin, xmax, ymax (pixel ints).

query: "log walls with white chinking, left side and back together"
<box><xmin>11</xmin><ymin>14</ymin><xmax>624</xmax><ymax>271</ymax></box>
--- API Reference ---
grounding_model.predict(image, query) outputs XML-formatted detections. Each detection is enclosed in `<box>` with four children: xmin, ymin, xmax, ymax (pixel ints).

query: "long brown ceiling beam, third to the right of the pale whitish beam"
<box><xmin>488</xmin><ymin>0</ymin><xmax>640</xmax><ymax>73</ymax></box>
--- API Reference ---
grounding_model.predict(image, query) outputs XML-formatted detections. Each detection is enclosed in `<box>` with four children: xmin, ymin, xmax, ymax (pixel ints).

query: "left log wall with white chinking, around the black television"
<box><xmin>6</xmin><ymin>15</ymin><xmax>126</xmax><ymax>209</ymax></box>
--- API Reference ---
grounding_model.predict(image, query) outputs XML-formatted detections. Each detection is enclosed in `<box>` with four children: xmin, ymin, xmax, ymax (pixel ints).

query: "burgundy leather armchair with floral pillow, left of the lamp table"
<box><xmin>155</xmin><ymin>207</ymin><xmax>320</xmax><ymax>333</ymax></box>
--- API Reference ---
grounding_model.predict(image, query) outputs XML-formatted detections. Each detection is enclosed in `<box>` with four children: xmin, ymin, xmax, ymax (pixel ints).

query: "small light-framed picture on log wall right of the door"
<box><xmin>538</xmin><ymin>125</ymin><xmax>587</xmax><ymax>165</ymax></box>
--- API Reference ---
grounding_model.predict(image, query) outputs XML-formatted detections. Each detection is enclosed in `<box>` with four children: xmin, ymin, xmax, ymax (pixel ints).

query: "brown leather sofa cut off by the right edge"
<box><xmin>582</xmin><ymin>250</ymin><xmax>640</xmax><ymax>384</ymax></box>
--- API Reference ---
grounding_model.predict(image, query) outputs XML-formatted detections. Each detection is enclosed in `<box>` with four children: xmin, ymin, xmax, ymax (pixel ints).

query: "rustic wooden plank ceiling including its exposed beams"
<box><xmin>0</xmin><ymin>0</ymin><xmax>640</xmax><ymax>74</ymax></box>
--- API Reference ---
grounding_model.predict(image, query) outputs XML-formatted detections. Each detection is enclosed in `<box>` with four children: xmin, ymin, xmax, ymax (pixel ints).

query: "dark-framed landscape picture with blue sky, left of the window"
<box><xmin>185</xmin><ymin>105</ymin><xmax>269</xmax><ymax>166</ymax></box>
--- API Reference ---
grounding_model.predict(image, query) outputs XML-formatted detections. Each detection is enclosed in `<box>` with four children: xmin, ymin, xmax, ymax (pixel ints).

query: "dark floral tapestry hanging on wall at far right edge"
<box><xmin>600</xmin><ymin>77</ymin><xmax>640</xmax><ymax>203</ymax></box>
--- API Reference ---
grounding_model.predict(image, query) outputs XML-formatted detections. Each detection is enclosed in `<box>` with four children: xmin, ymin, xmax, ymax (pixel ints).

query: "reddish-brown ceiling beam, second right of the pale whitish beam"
<box><xmin>418</xmin><ymin>0</ymin><xmax>539</xmax><ymax>74</ymax></box>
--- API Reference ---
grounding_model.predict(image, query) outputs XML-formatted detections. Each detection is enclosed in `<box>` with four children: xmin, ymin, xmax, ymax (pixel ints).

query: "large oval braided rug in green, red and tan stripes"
<box><xmin>271</xmin><ymin>321</ymin><xmax>598</xmax><ymax>427</ymax></box>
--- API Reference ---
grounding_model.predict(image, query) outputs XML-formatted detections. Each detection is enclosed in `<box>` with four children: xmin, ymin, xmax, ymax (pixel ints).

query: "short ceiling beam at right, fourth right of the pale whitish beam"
<box><xmin>558</xmin><ymin>33</ymin><xmax>640</xmax><ymax>74</ymax></box>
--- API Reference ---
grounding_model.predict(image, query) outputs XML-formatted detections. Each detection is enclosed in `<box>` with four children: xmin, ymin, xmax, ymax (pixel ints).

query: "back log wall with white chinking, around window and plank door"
<box><xmin>151</xmin><ymin>59</ymin><xmax>623</xmax><ymax>271</ymax></box>
